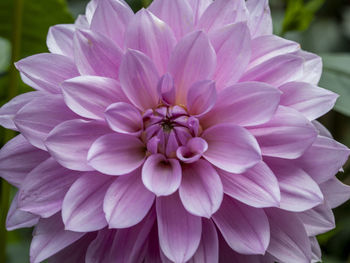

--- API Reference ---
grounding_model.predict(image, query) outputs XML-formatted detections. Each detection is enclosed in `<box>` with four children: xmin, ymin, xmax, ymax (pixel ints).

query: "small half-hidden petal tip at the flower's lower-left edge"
<box><xmin>6</xmin><ymin>194</ymin><xmax>40</xmax><ymax>231</ymax></box>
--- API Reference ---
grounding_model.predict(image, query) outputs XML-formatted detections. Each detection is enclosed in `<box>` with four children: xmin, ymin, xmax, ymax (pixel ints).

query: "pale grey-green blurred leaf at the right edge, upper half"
<box><xmin>320</xmin><ymin>53</ymin><xmax>350</xmax><ymax>116</ymax></box>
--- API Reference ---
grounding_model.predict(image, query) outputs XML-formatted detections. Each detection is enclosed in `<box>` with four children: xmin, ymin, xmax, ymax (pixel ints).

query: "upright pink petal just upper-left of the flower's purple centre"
<box><xmin>119</xmin><ymin>50</ymin><xmax>159</xmax><ymax>110</ymax></box>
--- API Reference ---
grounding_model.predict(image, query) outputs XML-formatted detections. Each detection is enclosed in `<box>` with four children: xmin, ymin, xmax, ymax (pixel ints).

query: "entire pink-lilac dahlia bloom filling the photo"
<box><xmin>0</xmin><ymin>0</ymin><xmax>350</xmax><ymax>263</ymax></box>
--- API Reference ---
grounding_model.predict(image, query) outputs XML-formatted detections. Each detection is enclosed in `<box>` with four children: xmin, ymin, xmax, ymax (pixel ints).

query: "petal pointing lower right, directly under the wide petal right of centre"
<box><xmin>218</xmin><ymin>162</ymin><xmax>281</xmax><ymax>208</ymax></box>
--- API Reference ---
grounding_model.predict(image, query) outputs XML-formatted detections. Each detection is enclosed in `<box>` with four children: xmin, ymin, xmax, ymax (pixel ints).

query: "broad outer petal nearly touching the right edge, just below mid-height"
<box><xmin>296</xmin><ymin>136</ymin><xmax>350</xmax><ymax>183</ymax></box>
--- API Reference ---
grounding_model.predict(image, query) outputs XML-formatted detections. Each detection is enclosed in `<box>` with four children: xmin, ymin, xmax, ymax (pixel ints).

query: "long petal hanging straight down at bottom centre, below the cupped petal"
<box><xmin>156</xmin><ymin>194</ymin><xmax>202</xmax><ymax>262</ymax></box>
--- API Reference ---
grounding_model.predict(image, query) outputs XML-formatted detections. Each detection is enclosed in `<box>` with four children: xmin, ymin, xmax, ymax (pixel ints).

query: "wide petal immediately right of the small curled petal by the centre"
<box><xmin>202</xmin><ymin>124</ymin><xmax>261</xmax><ymax>173</ymax></box>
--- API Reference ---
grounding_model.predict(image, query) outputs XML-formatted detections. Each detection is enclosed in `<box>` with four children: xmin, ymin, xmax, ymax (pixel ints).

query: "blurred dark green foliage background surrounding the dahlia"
<box><xmin>0</xmin><ymin>0</ymin><xmax>350</xmax><ymax>263</ymax></box>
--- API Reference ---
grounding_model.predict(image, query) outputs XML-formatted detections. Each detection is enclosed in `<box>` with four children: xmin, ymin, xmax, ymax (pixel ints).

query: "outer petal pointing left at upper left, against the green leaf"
<box><xmin>15</xmin><ymin>53</ymin><xmax>79</xmax><ymax>93</ymax></box>
